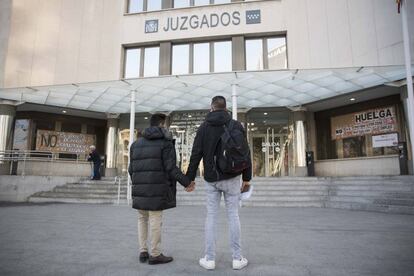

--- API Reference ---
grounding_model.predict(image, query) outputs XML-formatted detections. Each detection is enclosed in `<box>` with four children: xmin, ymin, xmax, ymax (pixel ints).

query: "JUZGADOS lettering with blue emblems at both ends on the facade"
<box><xmin>145</xmin><ymin>10</ymin><xmax>261</xmax><ymax>33</ymax></box>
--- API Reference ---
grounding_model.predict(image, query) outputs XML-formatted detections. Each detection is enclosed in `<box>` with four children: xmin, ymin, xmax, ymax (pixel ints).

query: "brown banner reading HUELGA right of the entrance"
<box><xmin>331</xmin><ymin>106</ymin><xmax>398</xmax><ymax>140</ymax></box>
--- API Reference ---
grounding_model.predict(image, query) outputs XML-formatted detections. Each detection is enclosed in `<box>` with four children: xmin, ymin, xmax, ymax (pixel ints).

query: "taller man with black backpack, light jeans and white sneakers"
<box><xmin>187</xmin><ymin>96</ymin><xmax>252</xmax><ymax>270</ymax></box>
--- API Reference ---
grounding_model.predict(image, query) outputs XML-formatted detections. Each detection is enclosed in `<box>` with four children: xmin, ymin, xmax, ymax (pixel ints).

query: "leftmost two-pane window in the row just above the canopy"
<box><xmin>124</xmin><ymin>47</ymin><xmax>160</xmax><ymax>79</ymax></box>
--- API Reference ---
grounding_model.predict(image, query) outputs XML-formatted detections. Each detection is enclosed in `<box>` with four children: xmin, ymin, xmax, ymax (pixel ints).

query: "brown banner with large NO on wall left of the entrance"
<box><xmin>36</xmin><ymin>130</ymin><xmax>95</xmax><ymax>153</ymax></box>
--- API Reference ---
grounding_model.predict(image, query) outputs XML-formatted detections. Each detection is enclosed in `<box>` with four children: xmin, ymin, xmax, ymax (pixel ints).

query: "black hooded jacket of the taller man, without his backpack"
<box><xmin>187</xmin><ymin>110</ymin><xmax>252</xmax><ymax>182</ymax></box>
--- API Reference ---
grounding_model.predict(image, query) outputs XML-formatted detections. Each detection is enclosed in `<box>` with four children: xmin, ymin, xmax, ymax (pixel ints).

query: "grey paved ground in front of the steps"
<box><xmin>0</xmin><ymin>204</ymin><xmax>414</xmax><ymax>276</ymax></box>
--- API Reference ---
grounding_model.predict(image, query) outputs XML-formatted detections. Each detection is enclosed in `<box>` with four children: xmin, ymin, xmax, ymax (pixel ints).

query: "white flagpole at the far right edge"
<box><xmin>401</xmin><ymin>0</ymin><xmax>414</xmax><ymax>162</ymax></box>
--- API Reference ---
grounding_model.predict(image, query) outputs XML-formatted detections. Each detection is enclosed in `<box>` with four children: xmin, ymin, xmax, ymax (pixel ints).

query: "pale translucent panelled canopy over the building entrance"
<box><xmin>0</xmin><ymin>66</ymin><xmax>414</xmax><ymax>113</ymax></box>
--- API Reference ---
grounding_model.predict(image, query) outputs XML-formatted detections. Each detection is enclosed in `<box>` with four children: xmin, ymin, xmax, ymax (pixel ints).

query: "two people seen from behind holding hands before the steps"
<box><xmin>128</xmin><ymin>96</ymin><xmax>252</xmax><ymax>270</ymax></box>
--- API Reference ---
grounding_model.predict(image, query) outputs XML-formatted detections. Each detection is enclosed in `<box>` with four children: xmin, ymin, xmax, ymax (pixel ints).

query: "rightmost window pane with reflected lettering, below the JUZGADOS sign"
<box><xmin>267</xmin><ymin>37</ymin><xmax>287</xmax><ymax>69</ymax></box>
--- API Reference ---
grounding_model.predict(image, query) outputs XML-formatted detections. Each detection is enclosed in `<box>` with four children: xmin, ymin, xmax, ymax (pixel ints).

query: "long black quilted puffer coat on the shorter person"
<box><xmin>128</xmin><ymin>127</ymin><xmax>190</xmax><ymax>211</ymax></box>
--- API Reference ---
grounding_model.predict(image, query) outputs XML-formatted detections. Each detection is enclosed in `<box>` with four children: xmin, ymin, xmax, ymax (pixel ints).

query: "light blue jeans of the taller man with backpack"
<box><xmin>205</xmin><ymin>176</ymin><xmax>242</xmax><ymax>261</ymax></box>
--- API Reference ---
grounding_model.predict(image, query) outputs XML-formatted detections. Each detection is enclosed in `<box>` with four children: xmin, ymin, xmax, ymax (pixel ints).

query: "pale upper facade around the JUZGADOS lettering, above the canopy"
<box><xmin>0</xmin><ymin>0</ymin><xmax>414</xmax><ymax>87</ymax></box>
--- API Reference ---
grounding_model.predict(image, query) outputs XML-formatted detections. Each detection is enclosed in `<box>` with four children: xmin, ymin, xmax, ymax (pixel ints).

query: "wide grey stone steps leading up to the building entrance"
<box><xmin>29</xmin><ymin>176</ymin><xmax>414</xmax><ymax>214</ymax></box>
